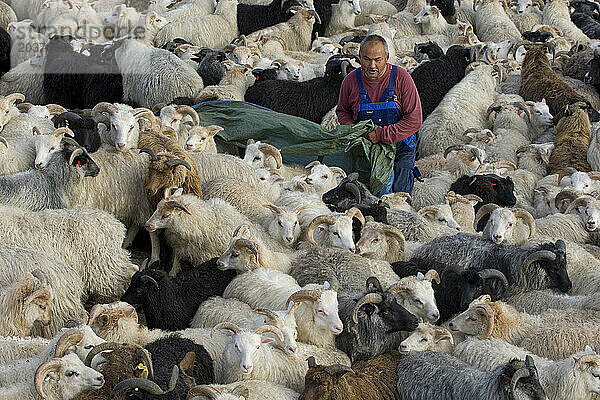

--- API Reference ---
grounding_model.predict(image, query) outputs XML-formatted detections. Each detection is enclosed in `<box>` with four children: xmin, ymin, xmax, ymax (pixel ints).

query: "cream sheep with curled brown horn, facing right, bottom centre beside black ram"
<box><xmin>223</xmin><ymin>268</ymin><xmax>343</xmax><ymax>347</ymax></box>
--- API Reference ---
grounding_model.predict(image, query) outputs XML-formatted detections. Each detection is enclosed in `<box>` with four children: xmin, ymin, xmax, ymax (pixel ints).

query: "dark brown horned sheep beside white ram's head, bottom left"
<box><xmin>73</xmin><ymin>342</ymin><xmax>153</xmax><ymax>400</ymax></box>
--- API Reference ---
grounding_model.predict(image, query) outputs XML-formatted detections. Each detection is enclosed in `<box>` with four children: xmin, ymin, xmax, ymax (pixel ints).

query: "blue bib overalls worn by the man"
<box><xmin>356</xmin><ymin>65</ymin><xmax>417</xmax><ymax>196</ymax></box>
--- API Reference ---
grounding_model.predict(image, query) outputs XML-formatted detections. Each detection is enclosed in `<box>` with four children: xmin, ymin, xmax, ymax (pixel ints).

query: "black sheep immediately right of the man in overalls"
<box><xmin>410</xmin><ymin>46</ymin><xmax>471</xmax><ymax>119</ymax></box>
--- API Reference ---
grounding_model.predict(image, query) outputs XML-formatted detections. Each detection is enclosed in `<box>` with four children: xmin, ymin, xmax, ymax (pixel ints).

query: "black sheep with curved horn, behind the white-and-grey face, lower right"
<box><xmin>392</xmin><ymin>258</ymin><xmax>508</xmax><ymax>324</ymax></box>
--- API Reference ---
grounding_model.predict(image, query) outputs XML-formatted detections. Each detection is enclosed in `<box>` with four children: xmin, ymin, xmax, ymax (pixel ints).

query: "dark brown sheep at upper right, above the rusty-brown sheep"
<box><xmin>515</xmin><ymin>43</ymin><xmax>587</xmax><ymax>122</ymax></box>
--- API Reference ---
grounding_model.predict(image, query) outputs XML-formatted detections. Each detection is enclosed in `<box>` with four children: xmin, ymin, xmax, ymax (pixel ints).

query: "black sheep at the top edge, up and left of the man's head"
<box><xmin>237</xmin><ymin>0</ymin><xmax>310</xmax><ymax>35</ymax></box>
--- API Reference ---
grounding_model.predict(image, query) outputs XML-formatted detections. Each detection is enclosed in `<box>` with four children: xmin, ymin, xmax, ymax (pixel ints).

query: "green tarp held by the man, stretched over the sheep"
<box><xmin>194</xmin><ymin>100</ymin><xmax>396</xmax><ymax>193</ymax></box>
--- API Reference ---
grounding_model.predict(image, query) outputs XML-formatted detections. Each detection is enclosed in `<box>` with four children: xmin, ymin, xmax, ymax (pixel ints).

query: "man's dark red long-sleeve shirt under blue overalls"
<box><xmin>336</xmin><ymin>64</ymin><xmax>423</xmax><ymax>143</ymax></box>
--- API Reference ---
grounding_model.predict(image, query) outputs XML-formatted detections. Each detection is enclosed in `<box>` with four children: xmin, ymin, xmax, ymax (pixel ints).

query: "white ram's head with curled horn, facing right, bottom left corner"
<box><xmin>35</xmin><ymin>354</ymin><xmax>104</xmax><ymax>399</ymax></box>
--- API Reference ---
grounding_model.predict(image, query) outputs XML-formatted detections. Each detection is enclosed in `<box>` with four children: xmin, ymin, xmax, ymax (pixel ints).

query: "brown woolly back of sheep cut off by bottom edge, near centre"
<box><xmin>298</xmin><ymin>351</ymin><xmax>400</xmax><ymax>400</ymax></box>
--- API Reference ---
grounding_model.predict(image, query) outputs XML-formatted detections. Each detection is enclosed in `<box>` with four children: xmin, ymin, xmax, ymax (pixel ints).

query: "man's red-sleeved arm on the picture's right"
<box><xmin>375</xmin><ymin>67</ymin><xmax>423</xmax><ymax>144</ymax></box>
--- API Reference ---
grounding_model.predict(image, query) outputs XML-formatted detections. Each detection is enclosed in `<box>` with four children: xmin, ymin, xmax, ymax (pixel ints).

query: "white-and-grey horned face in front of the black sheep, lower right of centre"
<box><xmin>388</xmin><ymin>271</ymin><xmax>440</xmax><ymax>322</ymax></box>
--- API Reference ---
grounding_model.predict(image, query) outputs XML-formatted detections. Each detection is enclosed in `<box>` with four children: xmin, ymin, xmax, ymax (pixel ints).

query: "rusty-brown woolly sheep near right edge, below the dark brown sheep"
<box><xmin>549</xmin><ymin>102</ymin><xmax>592</xmax><ymax>174</ymax></box>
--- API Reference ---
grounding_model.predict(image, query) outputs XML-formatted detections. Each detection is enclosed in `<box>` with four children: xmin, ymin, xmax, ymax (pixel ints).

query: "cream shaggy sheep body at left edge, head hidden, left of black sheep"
<box><xmin>2</xmin><ymin>206</ymin><xmax>137</xmax><ymax>300</ymax></box>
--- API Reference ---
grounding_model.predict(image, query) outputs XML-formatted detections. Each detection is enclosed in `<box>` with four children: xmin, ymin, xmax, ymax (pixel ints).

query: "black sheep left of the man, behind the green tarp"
<box><xmin>244</xmin><ymin>55</ymin><xmax>354</xmax><ymax>124</ymax></box>
